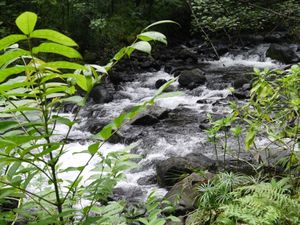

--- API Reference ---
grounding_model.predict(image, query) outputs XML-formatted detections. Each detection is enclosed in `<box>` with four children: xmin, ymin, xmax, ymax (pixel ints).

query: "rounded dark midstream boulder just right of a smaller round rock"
<box><xmin>178</xmin><ymin>68</ymin><xmax>206</xmax><ymax>89</ymax></box>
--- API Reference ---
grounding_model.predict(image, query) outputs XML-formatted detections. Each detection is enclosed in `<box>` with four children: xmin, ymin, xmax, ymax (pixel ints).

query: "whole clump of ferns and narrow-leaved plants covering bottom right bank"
<box><xmin>186</xmin><ymin>173</ymin><xmax>300</xmax><ymax>225</ymax></box>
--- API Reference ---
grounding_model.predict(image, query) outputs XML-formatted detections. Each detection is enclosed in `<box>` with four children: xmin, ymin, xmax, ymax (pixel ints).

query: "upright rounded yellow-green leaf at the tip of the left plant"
<box><xmin>16</xmin><ymin>12</ymin><xmax>37</xmax><ymax>34</ymax></box>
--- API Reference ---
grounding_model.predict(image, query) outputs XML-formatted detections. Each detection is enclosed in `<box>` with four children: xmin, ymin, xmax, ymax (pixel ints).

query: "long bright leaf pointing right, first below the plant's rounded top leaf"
<box><xmin>30</xmin><ymin>29</ymin><xmax>78</xmax><ymax>46</ymax></box>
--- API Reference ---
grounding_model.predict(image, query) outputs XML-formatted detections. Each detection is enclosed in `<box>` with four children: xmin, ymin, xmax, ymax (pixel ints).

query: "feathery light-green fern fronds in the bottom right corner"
<box><xmin>217</xmin><ymin>178</ymin><xmax>300</xmax><ymax>225</ymax></box>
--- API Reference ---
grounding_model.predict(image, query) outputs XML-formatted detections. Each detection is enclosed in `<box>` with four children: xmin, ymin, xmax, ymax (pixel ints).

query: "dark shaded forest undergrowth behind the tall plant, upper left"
<box><xmin>0</xmin><ymin>0</ymin><xmax>189</xmax><ymax>63</ymax></box>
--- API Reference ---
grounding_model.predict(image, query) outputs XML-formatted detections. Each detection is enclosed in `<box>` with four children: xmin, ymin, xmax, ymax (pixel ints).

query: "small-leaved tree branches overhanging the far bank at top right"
<box><xmin>192</xmin><ymin>0</ymin><xmax>300</xmax><ymax>33</ymax></box>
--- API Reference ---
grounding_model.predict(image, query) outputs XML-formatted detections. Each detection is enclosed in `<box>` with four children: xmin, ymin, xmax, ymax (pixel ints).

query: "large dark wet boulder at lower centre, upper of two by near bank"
<box><xmin>156</xmin><ymin>153</ymin><xmax>215</xmax><ymax>187</ymax></box>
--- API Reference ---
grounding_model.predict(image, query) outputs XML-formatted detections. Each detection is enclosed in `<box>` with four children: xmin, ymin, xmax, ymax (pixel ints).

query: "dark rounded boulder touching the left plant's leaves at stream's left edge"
<box><xmin>90</xmin><ymin>84</ymin><xmax>114</xmax><ymax>104</ymax></box>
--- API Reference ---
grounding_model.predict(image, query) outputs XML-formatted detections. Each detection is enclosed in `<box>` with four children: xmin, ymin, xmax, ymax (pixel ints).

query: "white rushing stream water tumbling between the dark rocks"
<box><xmin>52</xmin><ymin>45</ymin><xmax>278</xmax><ymax>199</ymax></box>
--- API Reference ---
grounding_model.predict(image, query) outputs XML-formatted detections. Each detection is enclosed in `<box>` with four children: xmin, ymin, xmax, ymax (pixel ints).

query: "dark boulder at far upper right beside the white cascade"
<box><xmin>266</xmin><ymin>44</ymin><xmax>300</xmax><ymax>64</ymax></box>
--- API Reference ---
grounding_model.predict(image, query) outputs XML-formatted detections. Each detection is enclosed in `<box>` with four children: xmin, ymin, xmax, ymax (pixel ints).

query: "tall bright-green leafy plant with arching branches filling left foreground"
<box><xmin>0</xmin><ymin>12</ymin><xmax>175</xmax><ymax>224</ymax></box>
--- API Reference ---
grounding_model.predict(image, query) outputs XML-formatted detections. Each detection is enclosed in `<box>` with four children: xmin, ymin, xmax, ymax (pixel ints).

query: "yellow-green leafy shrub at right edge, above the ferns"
<box><xmin>238</xmin><ymin>65</ymin><xmax>300</xmax><ymax>168</ymax></box>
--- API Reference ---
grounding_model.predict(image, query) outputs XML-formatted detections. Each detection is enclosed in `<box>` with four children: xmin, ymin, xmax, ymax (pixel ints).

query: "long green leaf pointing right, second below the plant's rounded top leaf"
<box><xmin>32</xmin><ymin>43</ymin><xmax>82</xmax><ymax>59</ymax></box>
